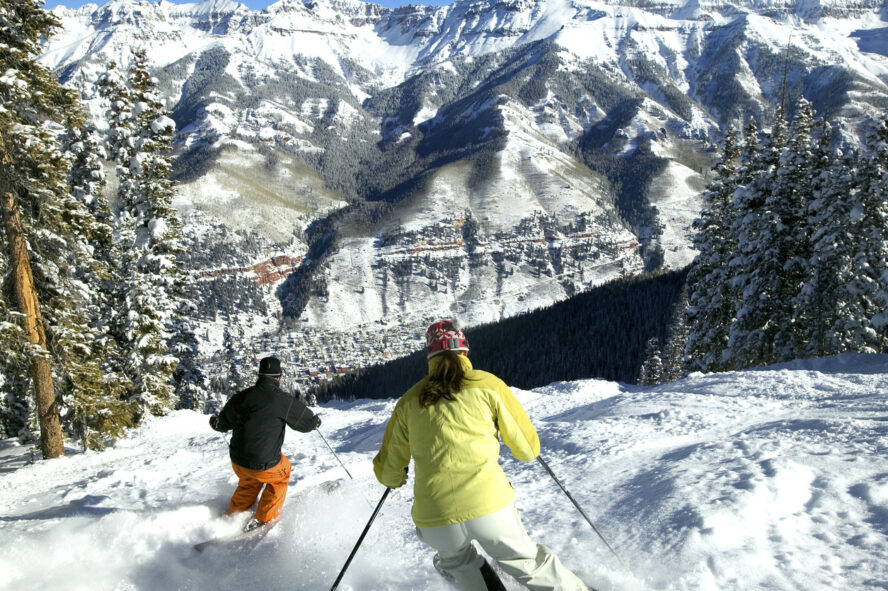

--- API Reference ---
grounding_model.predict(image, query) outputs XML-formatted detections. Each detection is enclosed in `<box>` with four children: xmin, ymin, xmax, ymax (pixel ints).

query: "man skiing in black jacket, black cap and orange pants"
<box><xmin>210</xmin><ymin>357</ymin><xmax>321</xmax><ymax>530</ymax></box>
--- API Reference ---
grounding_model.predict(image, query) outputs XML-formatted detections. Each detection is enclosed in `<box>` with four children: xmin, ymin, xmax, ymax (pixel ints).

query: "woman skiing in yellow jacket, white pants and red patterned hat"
<box><xmin>373</xmin><ymin>320</ymin><xmax>587</xmax><ymax>591</ymax></box>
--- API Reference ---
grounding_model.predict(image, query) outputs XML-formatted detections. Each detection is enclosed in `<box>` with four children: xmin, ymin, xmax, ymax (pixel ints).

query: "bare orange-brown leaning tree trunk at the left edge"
<box><xmin>0</xmin><ymin>187</ymin><xmax>65</xmax><ymax>459</ymax></box>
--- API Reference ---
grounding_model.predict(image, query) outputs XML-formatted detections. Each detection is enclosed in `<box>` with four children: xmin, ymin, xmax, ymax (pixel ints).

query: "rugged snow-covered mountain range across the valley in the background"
<box><xmin>42</xmin><ymin>0</ymin><xmax>888</xmax><ymax>342</ymax></box>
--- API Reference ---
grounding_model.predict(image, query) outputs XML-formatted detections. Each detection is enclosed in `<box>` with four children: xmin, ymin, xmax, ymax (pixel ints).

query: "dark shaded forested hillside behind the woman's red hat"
<box><xmin>315</xmin><ymin>271</ymin><xmax>686</xmax><ymax>400</ymax></box>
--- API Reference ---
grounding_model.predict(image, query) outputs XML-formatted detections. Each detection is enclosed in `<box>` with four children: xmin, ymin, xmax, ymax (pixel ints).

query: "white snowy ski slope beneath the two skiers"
<box><xmin>0</xmin><ymin>355</ymin><xmax>888</xmax><ymax>591</ymax></box>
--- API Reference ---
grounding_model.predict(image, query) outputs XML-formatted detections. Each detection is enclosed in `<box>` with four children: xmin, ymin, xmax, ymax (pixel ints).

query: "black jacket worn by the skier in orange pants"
<box><xmin>215</xmin><ymin>376</ymin><xmax>320</xmax><ymax>470</ymax></box>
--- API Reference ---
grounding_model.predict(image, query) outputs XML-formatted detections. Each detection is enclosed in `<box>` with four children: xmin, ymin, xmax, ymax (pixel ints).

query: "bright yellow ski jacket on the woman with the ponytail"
<box><xmin>373</xmin><ymin>356</ymin><xmax>540</xmax><ymax>527</ymax></box>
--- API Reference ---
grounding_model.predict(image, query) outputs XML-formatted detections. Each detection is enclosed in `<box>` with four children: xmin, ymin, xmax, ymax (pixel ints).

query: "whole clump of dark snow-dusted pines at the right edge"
<box><xmin>685</xmin><ymin>98</ymin><xmax>888</xmax><ymax>371</ymax></box>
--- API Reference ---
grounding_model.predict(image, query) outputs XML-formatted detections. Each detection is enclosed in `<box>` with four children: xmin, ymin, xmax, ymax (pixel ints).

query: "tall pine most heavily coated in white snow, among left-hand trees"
<box><xmin>109</xmin><ymin>49</ymin><xmax>187</xmax><ymax>414</ymax></box>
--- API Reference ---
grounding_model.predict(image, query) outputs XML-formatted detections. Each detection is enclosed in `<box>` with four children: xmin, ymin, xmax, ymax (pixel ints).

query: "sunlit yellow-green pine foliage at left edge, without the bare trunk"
<box><xmin>0</xmin><ymin>0</ymin><xmax>137</xmax><ymax>453</ymax></box>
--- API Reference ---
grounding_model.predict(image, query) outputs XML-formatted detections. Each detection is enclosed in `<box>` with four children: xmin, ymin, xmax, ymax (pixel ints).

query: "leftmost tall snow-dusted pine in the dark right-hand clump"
<box><xmin>685</xmin><ymin>130</ymin><xmax>740</xmax><ymax>371</ymax></box>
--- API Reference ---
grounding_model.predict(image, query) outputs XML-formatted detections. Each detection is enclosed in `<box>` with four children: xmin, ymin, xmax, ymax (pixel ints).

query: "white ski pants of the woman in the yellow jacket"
<box><xmin>416</xmin><ymin>505</ymin><xmax>588</xmax><ymax>591</ymax></box>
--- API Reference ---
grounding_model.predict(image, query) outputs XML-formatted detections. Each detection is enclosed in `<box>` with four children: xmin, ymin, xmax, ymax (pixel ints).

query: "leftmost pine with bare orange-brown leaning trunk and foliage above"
<box><xmin>0</xmin><ymin>0</ymin><xmax>83</xmax><ymax>458</ymax></box>
